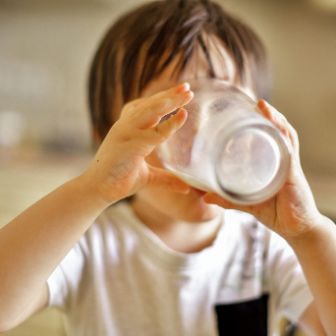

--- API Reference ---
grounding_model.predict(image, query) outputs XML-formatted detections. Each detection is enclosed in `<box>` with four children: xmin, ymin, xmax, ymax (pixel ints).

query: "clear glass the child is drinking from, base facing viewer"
<box><xmin>158</xmin><ymin>79</ymin><xmax>290</xmax><ymax>204</ymax></box>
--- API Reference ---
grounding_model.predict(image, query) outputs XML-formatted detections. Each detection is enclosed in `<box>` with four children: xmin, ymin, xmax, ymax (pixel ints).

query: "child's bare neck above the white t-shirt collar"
<box><xmin>131</xmin><ymin>198</ymin><xmax>221</xmax><ymax>253</ymax></box>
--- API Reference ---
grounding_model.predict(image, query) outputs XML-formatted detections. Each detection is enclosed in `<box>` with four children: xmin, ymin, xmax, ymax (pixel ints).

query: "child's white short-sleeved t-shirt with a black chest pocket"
<box><xmin>48</xmin><ymin>203</ymin><xmax>312</xmax><ymax>336</ymax></box>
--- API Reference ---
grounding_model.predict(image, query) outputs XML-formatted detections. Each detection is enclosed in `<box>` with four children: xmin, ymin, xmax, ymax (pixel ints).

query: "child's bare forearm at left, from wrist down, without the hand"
<box><xmin>0</xmin><ymin>173</ymin><xmax>107</xmax><ymax>319</ymax></box>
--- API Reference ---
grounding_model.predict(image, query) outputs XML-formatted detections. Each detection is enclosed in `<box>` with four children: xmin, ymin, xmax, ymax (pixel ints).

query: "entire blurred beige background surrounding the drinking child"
<box><xmin>0</xmin><ymin>0</ymin><xmax>336</xmax><ymax>336</ymax></box>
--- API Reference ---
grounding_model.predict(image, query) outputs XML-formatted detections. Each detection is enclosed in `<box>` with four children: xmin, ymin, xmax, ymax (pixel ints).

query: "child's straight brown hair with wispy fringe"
<box><xmin>89</xmin><ymin>0</ymin><xmax>269</xmax><ymax>139</ymax></box>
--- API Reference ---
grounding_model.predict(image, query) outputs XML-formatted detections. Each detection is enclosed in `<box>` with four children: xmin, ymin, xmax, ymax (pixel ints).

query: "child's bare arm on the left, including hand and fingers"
<box><xmin>0</xmin><ymin>85</ymin><xmax>192</xmax><ymax>331</ymax></box>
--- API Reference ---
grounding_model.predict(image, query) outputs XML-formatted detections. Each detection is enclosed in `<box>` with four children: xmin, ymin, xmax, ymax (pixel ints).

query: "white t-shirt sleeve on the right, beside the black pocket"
<box><xmin>268</xmin><ymin>233</ymin><xmax>313</xmax><ymax>322</ymax></box>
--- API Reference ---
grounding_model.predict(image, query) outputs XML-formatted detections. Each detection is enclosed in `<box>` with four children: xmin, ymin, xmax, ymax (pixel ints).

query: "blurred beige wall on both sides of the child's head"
<box><xmin>0</xmin><ymin>0</ymin><xmax>336</xmax><ymax>175</ymax></box>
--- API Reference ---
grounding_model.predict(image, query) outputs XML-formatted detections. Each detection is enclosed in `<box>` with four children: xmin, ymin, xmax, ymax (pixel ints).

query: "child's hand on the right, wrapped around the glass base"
<box><xmin>204</xmin><ymin>100</ymin><xmax>321</xmax><ymax>239</ymax></box>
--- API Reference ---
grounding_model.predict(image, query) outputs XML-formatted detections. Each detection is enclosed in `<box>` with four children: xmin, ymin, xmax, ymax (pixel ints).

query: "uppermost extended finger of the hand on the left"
<box><xmin>124</xmin><ymin>83</ymin><xmax>193</xmax><ymax>129</ymax></box>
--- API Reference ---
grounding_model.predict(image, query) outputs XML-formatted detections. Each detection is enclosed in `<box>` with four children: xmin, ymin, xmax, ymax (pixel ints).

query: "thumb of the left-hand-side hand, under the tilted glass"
<box><xmin>148</xmin><ymin>166</ymin><xmax>190</xmax><ymax>194</ymax></box>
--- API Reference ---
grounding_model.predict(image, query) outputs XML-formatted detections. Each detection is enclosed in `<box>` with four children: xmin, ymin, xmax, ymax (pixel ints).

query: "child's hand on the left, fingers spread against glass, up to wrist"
<box><xmin>81</xmin><ymin>83</ymin><xmax>193</xmax><ymax>204</ymax></box>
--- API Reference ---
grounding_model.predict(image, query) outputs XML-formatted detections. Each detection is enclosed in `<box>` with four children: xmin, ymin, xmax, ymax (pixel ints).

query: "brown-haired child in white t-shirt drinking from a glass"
<box><xmin>0</xmin><ymin>0</ymin><xmax>336</xmax><ymax>336</ymax></box>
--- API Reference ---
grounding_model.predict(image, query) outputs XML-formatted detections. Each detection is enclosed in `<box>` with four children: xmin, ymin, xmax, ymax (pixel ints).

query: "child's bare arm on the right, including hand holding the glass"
<box><xmin>205</xmin><ymin>101</ymin><xmax>336</xmax><ymax>335</ymax></box>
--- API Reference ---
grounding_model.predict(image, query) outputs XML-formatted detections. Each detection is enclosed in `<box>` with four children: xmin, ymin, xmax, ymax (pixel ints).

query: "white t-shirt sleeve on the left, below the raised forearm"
<box><xmin>47</xmin><ymin>241</ymin><xmax>85</xmax><ymax>309</ymax></box>
